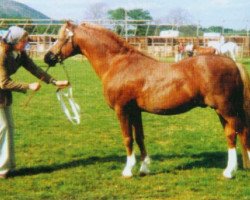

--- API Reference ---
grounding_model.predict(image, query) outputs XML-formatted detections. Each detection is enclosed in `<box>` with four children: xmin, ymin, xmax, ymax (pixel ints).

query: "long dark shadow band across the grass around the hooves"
<box><xmin>11</xmin><ymin>152</ymin><xmax>242</xmax><ymax>177</ymax></box>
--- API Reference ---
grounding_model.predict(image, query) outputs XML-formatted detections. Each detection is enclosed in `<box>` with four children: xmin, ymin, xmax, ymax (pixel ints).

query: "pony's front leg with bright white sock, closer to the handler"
<box><xmin>116</xmin><ymin>108</ymin><xmax>136</xmax><ymax>178</ymax></box>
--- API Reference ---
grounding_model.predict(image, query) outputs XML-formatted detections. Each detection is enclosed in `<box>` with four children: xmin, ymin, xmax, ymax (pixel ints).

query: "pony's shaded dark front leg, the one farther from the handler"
<box><xmin>131</xmin><ymin>109</ymin><xmax>150</xmax><ymax>176</ymax></box>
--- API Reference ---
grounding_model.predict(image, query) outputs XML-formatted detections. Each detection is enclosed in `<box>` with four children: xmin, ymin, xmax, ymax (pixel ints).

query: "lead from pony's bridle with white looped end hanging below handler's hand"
<box><xmin>56</xmin><ymin>63</ymin><xmax>80</xmax><ymax>124</ymax></box>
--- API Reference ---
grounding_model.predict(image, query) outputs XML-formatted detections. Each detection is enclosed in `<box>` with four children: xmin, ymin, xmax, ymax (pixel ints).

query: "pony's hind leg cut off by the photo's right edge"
<box><xmin>239</xmin><ymin>128</ymin><xmax>250</xmax><ymax>169</ymax></box>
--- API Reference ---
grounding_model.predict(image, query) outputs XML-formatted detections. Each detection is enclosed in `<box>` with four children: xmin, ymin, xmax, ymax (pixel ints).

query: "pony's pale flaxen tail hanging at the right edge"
<box><xmin>237</xmin><ymin>63</ymin><xmax>250</xmax><ymax>128</ymax></box>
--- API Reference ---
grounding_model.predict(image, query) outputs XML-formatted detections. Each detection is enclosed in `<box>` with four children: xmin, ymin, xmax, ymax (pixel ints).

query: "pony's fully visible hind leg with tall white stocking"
<box><xmin>221</xmin><ymin>117</ymin><xmax>238</xmax><ymax>178</ymax></box>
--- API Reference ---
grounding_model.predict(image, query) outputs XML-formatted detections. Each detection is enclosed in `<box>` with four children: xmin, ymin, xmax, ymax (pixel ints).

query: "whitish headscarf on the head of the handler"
<box><xmin>3</xmin><ymin>26</ymin><xmax>27</xmax><ymax>45</ymax></box>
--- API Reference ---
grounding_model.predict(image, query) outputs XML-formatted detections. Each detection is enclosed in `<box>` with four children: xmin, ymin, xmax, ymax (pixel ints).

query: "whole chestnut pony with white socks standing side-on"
<box><xmin>45</xmin><ymin>22</ymin><xmax>250</xmax><ymax>178</ymax></box>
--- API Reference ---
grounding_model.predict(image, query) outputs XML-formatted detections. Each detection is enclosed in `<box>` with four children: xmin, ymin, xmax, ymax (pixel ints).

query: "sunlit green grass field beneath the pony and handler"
<box><xmin>0</xmin><ymin>59</ymin><xmax>250</xmax><ymax>200</ymax></box>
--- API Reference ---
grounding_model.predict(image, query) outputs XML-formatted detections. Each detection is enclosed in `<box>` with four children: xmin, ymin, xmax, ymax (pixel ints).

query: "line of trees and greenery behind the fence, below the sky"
<box><xmin>1</xmin><ymin>3</ymin><xmax>247</xmax><ymax>37</ymax></box>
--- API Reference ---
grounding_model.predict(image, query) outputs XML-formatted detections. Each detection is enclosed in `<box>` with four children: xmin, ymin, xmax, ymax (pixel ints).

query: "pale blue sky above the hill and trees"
<box><xmin>16</xmin><ymin>0</ymin><xmax>250</xmax><ymax>29</ymax></box>
